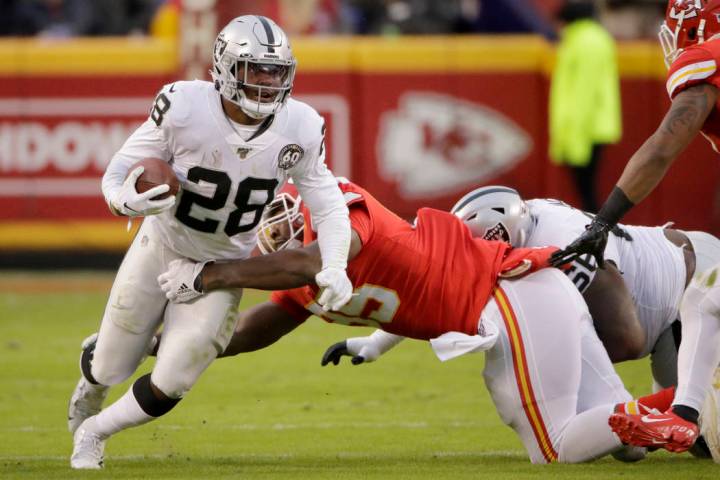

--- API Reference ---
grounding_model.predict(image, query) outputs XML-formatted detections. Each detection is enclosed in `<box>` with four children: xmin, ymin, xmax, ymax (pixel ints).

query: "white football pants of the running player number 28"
<box><xmin>92</xmin><ymin>222</ymin><xmax>242</xmax><ymax>398</ymax></box>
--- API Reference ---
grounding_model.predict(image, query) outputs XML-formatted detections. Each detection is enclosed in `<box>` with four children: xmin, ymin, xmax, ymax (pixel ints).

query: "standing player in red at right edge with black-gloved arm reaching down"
<box><xmin>553</xmin><ymin>0</ymin><xmax>720</xmax><ymax>462</ymax></box>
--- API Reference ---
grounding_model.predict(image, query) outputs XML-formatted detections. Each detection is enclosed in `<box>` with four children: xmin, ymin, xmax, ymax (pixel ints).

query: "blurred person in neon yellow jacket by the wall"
<box><xmin>550</xmin><ymin>0</ymin><xmax>622</xmax><ymax>212</ymax></box>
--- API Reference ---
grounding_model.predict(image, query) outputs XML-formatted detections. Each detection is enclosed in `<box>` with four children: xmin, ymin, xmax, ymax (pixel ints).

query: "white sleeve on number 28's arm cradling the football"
<box><xmin>102</xmin><ymin>118</ymin><xmax>172</xmax><ymax>208</ymax></box>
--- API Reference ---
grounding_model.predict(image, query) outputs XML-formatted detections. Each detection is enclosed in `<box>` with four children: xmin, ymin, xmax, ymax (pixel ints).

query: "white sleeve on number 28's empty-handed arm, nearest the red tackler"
<box><xmin>289</xmin><ymin>143</ymin><xmax>350</xmax><ymax>269</ymax></box>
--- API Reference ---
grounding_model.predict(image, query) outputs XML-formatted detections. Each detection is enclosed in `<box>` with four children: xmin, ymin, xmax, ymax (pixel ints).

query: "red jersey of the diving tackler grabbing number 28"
<box><xmin>271</xmin><ymin>183</ymin><xmax>510</xmax><ymax>340</ymax></box>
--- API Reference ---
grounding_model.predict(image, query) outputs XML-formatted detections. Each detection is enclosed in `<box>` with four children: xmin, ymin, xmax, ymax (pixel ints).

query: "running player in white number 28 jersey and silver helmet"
<box><xmin>68</xmin><ymin>15</ymin><xmax>352</xmax><ymax>469</ymax></box>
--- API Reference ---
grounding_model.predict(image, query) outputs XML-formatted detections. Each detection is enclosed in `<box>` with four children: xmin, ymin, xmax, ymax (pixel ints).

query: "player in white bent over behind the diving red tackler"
<box><xmin>452</xmin><ymin>186</ymin><xmax>720</xmax><ymax>387</ymax></box>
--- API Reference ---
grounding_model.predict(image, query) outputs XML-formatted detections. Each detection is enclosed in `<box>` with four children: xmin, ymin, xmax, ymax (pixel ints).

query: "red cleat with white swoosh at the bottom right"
<box><xmin>608</xmin><ymin>411</ymin><xmax>698</xmax><ymax>453</ymax></box>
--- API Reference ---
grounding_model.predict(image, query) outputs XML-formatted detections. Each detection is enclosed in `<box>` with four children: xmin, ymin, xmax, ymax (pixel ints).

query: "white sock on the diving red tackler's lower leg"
<box><xmin>558</xmin><ymin>405</ymin><xmax>622</xmax><ymax>463</ymax></box>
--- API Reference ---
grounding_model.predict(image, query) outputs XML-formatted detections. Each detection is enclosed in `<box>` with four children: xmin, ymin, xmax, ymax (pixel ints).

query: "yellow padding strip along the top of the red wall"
<box><xmin>0</xmin><ymin>35</ymin><xmax>667</xmax><ymax>79</ymax></box>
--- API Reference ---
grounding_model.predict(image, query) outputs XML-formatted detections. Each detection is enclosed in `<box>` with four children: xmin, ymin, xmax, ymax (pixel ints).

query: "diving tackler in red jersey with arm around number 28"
<box><xmin>159</xmin><ymin>178</ymin><xmax>672</xmax><ymax>463</ymax></box>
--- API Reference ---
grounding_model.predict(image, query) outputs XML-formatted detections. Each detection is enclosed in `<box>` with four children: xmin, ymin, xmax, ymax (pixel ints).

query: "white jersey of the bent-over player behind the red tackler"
<box><xmin>525</xmin><ymin>199</ymin><xmax>685</xmax><ymax>355</ymax></box>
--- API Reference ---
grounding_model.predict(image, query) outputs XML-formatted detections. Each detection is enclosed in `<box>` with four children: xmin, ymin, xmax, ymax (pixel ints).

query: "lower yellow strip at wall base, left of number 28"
<box><xmin>0</xmin><ymin>219</ymin><xmax>140</xmax><ymax>251</ymax></box>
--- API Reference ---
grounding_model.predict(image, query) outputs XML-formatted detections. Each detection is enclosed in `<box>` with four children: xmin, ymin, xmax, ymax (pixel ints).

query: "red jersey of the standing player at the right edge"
<box><xmin>666</xmin><ymin>39</ymin><xmax>720</xmax><ymax>153</ymax></box>
